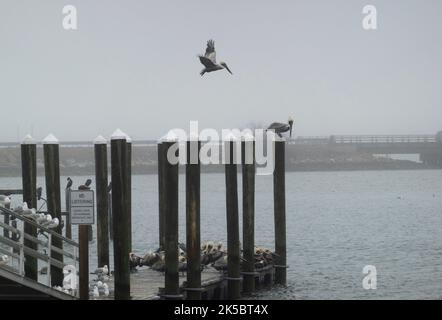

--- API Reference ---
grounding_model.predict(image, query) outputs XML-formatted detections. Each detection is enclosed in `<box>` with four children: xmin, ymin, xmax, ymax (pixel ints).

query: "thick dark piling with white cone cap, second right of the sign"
<box><xmin>111</xmin><ymin>129</ymin><xmax>130</xmax><ymax>300</ymax></box>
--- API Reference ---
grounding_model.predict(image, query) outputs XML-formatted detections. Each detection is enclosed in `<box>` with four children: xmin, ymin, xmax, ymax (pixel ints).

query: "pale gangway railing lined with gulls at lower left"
<box><xmin>0</xmin><ymin>207</ymin><xmax>79</xmax><ymax>297</ymax></box>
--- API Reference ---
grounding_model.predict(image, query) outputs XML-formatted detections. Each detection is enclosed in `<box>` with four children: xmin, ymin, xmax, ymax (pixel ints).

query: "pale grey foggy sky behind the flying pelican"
<box><xmin>0</xmin><ymin>0</ymin><xmax>442</xmax><ymax>141</ymax></box>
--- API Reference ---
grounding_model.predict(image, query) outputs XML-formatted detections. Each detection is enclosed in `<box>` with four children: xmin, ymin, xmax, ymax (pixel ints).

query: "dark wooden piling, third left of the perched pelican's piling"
<box><xmin>186</xmin><ymin>139</ymin><xmax>201</xmax><ymax>300</ymax></box>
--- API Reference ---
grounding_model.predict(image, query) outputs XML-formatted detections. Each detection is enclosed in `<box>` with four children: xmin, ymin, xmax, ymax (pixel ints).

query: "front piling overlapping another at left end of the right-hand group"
<box><xmin>163</xmin><ymin>139</ymin><xmax>179</xmax><ymax>299</ymax></box>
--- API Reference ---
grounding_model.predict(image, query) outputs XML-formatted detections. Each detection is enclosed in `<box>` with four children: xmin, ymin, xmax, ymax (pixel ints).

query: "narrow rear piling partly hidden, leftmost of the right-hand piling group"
<box><xmin>157</xmin><ymin>141</ymin><xmax>167</xmax><ymax>248</ymax></box>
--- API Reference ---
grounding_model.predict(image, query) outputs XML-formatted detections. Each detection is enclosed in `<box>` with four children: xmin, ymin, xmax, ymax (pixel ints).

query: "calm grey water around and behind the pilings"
<box><xmin>0</xmin><ymin>170</ymin><xmax>442</xmax><ymax>299</ymax></box>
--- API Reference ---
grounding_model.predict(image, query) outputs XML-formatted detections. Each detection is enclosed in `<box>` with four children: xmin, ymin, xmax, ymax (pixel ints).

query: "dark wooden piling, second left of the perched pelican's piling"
<box><xmin>224</xmin><ymin>134</ymin><xmax>241</xmax><ymax>299</ymax></box>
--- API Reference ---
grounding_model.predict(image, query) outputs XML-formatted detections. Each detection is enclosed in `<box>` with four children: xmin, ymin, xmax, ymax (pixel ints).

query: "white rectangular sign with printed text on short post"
<box><xmin>69</xmin><ymin>190</ymin><xmax>94</xmax><ymax>224</ymax></box>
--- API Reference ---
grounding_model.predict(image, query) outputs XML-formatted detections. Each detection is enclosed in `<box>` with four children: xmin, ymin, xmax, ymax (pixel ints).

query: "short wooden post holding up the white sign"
<box><xmin>78</xmin><ymin>224</ymin><xmax>89</xmax><ymax>300</ymax></box>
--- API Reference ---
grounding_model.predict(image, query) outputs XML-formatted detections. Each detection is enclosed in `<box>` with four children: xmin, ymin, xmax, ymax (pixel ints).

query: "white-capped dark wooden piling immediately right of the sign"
<box><xmin>94</xmin><ymin>136</ymin><xmax>110</xmax><ymax>267</ymax></box>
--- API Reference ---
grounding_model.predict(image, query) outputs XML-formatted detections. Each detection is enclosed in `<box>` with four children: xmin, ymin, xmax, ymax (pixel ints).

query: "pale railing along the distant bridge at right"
<box><xmin>330</xmin><ymin>135</ymin><xmax>436</xmax><ymax>143</ymax></box>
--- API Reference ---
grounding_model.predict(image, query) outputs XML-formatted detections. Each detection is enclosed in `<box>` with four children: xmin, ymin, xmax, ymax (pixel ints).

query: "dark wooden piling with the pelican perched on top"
<box><xmin>273</xmin><ymin>138</ymin><xmax>287</xmax><ymax>286</ymax></box>
